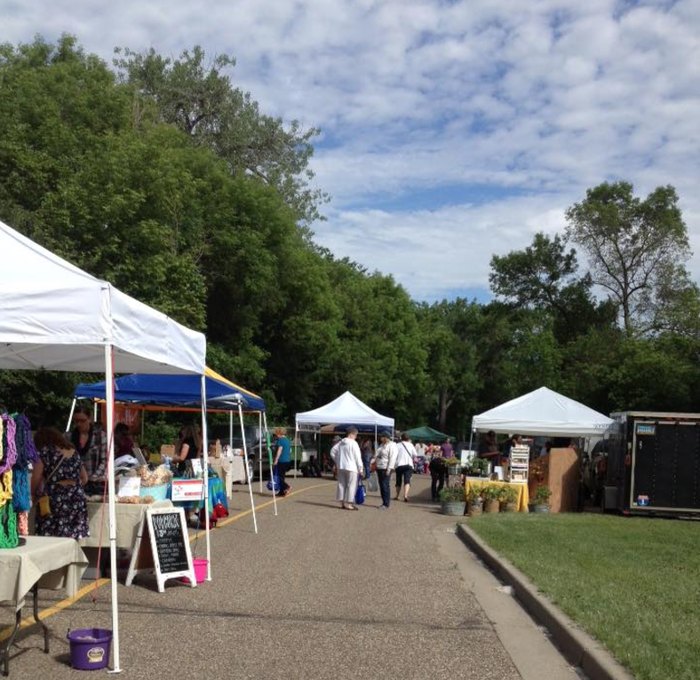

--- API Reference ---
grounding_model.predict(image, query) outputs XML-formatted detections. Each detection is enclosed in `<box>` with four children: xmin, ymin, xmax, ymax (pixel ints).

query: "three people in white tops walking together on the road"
<box><xmin>331</xmin><ymin>427</ymin><xmax>416</xmax><ymax>510</ymax></box>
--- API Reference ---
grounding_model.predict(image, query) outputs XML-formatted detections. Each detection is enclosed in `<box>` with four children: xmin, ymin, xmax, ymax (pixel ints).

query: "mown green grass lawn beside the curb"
<box><xmin>468</xmin><ymin>513</ymin><xmax>700</xmax><ymax>680</ymax></box>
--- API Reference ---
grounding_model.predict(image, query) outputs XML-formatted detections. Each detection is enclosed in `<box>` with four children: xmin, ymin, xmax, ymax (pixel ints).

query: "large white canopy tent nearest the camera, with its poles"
<box><xmin>0</xmin><ymin>222</ymin><xmax>209</xmax><ymax>671</ymax></box>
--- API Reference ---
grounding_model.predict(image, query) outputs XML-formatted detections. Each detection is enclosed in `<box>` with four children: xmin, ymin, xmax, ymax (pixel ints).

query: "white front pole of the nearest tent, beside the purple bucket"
<box><xmin>105</xmin><ymin>345</ymin><xmax>121</xmax><ymax>673</ymax></box>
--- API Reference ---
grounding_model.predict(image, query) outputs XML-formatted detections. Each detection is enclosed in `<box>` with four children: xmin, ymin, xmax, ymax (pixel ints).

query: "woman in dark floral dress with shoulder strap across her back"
<box><xmin>32</xmin><ymin>427</ymin><xmax>90</xmax><ymax>539</ymax></box>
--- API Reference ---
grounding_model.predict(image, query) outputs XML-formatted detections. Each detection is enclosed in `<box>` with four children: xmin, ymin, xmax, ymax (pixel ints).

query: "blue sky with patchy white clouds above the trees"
<box><xmin>5</xmin><ymin>0</ymin><xmax>700</xmax><ymax>301</ymax></box>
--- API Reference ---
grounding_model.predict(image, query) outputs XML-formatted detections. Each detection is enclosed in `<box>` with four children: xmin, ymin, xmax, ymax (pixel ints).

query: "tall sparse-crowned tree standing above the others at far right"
<box><xmin>566</xmin><ymin>182</ymin><xmax>690</xmax><ymax>337</ymax></box>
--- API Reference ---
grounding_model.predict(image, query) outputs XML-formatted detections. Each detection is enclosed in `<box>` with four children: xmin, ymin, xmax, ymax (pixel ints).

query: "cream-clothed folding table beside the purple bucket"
<box><xmin>0</xmin><ymin>536</ymin><xmax>88</xmax><ymax>675</ymax></box>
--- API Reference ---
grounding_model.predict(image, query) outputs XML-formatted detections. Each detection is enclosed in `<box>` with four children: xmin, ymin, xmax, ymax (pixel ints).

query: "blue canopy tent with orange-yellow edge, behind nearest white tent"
<box><xmin>68</xmin><ymin>367</ymin><xmax>266</xmax><ymax>534</ymax></box>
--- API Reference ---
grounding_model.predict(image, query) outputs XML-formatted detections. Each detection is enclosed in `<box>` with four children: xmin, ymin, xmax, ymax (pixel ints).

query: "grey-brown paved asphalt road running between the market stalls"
<box><xmin>0</xmin><ymin>476</ymin><xmax>578</xmax><ymax>680</ymax></box>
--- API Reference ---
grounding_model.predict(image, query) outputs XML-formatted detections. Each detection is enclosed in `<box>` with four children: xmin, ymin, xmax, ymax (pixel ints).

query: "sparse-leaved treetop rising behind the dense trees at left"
<box><xmin>114</xmin><ymin>46</ymin><xmax>328</xmax><ymax>225</ymax></box>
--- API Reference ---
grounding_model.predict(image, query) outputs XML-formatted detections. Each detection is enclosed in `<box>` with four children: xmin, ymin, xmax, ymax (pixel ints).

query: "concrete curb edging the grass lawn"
<box><xmin>457</xmin><ymin>524</ymin><xmax>634</xmax><ymax>680</ymax></box>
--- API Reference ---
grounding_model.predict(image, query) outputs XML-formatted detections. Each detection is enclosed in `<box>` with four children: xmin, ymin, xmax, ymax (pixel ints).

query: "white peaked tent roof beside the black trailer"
<box><xmin>472</xmin><ymin>387</ymin><xmax>614</xmax><ymax>437</ymax></box>
